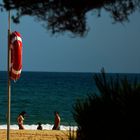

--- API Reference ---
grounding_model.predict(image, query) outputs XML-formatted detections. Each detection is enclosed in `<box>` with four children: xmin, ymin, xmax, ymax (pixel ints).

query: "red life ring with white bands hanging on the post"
<box><xmin>10</xmin><ymin>31</ymin><xmax>22</xmax><ymax>80</ymax></box>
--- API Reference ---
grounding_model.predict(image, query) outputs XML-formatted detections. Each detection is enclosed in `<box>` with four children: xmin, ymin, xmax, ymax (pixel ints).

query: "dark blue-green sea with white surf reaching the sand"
<box><xmin>0</xmin><ymin>71</ymin><xmax>140</xmax><ymax>130</ymax></box>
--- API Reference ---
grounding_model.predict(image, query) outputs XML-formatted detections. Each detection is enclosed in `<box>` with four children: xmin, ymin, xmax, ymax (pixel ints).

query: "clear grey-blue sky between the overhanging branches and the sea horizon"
<box><xmin>0</xmin><ymin>3</ymin><xmax>140</xmax><ymax>73</ymax></box>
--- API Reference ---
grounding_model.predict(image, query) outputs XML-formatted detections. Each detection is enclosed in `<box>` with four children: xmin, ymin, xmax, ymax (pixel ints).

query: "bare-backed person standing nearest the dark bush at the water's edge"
<box><xmin>52</xmin><ymin>112</ymin><xmax>61</xmax><ymax>130</ymax></box>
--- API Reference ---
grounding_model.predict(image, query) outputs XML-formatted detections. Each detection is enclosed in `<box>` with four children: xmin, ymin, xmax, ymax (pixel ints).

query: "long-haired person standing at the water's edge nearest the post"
<box><xmin>17</xmin><ymin>111</ymin><xmax>26</xmax><ymax>129</ymax></box>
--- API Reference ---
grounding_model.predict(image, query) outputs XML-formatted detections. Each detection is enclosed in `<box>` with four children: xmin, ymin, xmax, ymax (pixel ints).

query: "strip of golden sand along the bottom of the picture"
<box><xmin>0</xmin><ymin>130</ymin><xmax>75</xmax><ymax>140</ymax></box>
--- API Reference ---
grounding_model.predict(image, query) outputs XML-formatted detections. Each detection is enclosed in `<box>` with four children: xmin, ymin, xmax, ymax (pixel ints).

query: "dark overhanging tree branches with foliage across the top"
<box><xmin>0</xmin><ymin>0</ymin><xmax>140</xmax><ymax>36</ymax></box>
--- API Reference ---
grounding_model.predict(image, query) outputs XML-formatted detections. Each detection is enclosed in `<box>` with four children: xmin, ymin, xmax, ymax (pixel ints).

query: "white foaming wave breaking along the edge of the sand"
<box><xmin>0</xmin><ymin>124</ymin><xmax>77</xmax><ymax>131</ymax></box>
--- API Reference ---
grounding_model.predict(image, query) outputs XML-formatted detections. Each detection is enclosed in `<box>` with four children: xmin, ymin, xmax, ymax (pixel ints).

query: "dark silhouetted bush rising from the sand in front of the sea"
<box><xmin>73</xmin><ymin>68</ymin><xmax>140</xmax><ymax>140</ymax></box>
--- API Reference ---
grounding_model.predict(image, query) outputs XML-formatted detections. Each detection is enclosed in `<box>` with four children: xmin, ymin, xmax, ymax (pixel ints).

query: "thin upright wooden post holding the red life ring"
<box><xmin>7</xmin><ymin>11</ymin><xmax>11</xmax><ymax>140</ymax></box>
